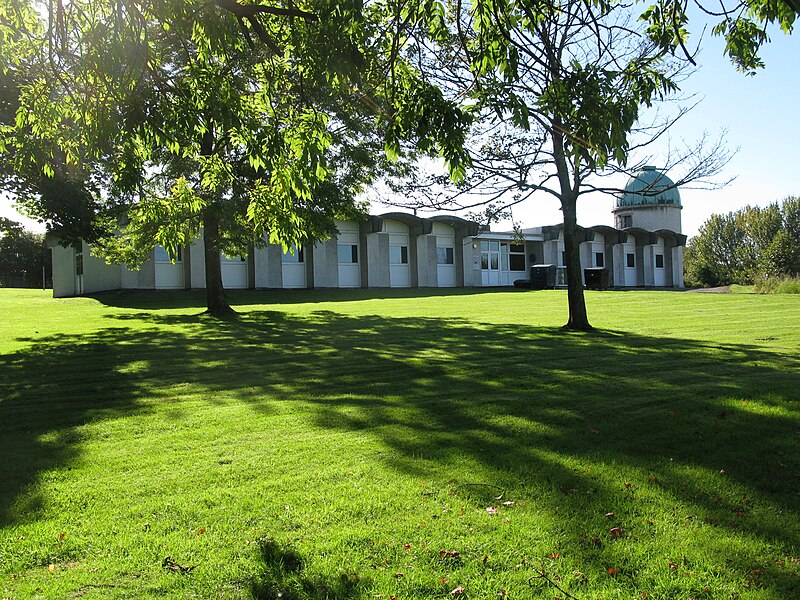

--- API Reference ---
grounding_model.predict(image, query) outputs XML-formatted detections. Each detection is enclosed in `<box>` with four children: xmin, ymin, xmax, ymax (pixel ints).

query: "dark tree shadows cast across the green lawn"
<box><xmin>0</xmin><ymin>310</ymin><xmax>800</xmax><ymax>598</ymax></box>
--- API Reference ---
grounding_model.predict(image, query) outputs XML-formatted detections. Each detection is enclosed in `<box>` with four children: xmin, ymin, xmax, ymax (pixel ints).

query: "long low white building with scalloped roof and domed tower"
<box><xmin>50</xmin><ymin>166</ymin><xmax>686</xmax><ymax>297</ymax></box>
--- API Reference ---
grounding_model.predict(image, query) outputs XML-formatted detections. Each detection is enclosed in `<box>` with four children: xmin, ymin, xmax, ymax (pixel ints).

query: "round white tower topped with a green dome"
<box><xmin>612</xmin><ymin>166</ymin><xmax>682</xmax><ymax>233</ymax></box>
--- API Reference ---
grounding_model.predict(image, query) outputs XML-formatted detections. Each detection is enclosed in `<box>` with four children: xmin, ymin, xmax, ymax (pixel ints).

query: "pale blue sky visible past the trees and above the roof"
<box><xmin>0</xmin><ymin>16</ymin><xmax>800</xmax><ymax>236</ymax></box>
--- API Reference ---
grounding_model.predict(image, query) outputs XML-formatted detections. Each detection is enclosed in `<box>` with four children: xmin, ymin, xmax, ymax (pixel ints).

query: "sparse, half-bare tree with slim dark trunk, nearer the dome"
<box><xmin>378</xmin><ymin>0</ymin><xmax>727</xmax><ymax>330</ymax></box>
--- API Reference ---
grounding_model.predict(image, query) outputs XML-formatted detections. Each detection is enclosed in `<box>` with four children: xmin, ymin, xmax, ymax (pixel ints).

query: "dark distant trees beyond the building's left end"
<box><xmin>0</xmin><ymin>217</ymin><xmax>52</xmax><ymax>287</ymax></box>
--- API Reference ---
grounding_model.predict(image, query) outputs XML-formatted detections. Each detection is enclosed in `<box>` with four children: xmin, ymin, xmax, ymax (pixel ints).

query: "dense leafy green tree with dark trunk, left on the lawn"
<box><xmin>0</xmin><ymin>0</ymin><xmax>468</xmax><ymax>312</ymax></box>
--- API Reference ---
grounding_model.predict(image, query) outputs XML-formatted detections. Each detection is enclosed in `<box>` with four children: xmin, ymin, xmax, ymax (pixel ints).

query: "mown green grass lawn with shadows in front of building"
<box><xmin>0</xmin><ymin>289</ymin><xmax>800</xmax><ymax>600</ymax></box>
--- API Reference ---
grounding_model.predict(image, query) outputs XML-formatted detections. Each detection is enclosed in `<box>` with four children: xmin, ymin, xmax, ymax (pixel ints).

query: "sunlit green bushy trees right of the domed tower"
<box><xmin>685</xmin><ymin>197</ymin><xmax>800</xmax><ymax>287</ymax></box>
